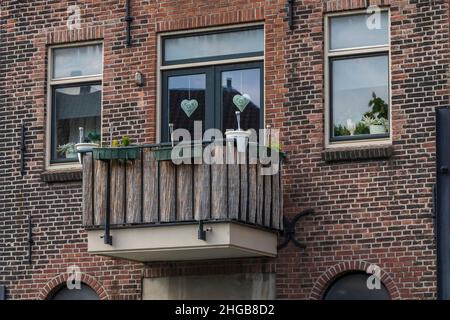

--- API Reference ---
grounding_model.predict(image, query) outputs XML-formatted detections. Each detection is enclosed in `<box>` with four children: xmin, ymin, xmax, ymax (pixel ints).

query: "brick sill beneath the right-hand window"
<box><xmin>322</xmin><ymin>144</ymin><xmax>393</xmax><ymax>162</ymax></box>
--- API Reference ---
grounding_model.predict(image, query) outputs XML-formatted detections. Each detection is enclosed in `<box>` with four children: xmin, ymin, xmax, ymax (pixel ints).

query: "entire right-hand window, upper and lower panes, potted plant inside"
<box><xmin>326</xmin><ymin>11</ymin><xmax>390</xmax><ymax>142</ymax></box>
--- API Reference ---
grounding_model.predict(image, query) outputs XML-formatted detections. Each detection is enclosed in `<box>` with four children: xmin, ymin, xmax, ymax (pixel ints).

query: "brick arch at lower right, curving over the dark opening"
<box><xmin>309</xmin><ymin>261</ymin><xmax>400</xmax><ymax>300</ymax></box>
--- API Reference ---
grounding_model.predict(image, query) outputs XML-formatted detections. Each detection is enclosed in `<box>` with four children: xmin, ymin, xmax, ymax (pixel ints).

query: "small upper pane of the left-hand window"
<box><xmin>53</xmin><ymin>44</ymin><xmax>102</xmax><ymax>79</ymax></box>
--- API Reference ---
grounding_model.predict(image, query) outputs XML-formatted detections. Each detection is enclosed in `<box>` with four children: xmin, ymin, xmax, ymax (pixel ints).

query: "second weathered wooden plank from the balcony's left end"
<box><xmin>94</xmin><ymin>160</ymin><xmax>108</xmax><ymax>225</ymax></box>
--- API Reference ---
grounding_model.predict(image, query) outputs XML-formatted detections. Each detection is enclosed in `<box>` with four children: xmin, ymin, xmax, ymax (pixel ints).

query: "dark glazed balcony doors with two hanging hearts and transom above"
<box><xmin>161</xmin><ymin>27</ymin><xmax>264</xmax><ymax>141</ymax></box>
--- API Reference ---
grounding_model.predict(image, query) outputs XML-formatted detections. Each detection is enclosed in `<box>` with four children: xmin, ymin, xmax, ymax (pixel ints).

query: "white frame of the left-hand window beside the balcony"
<box><xmin>45</xmin><ymin>41</ymin><xmax>104</xmax><ymax>171</ymax></box>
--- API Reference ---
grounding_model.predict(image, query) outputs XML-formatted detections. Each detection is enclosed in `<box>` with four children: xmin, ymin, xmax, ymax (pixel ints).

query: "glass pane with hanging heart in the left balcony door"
<box><xmin>168</xmin><ymin>74</ymin><xmax>206</xmax><ymax>137</ymax></box>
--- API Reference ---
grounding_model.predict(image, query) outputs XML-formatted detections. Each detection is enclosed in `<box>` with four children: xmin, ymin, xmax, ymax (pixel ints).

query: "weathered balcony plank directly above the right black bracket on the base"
<box><xmin>194</xmin><ymin>164</ymin><xmax>211</xmax><ymax>220</ymax></box>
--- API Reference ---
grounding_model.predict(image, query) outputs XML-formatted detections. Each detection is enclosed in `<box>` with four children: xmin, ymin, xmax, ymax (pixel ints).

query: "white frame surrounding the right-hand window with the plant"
<box><xmin>324</xmin><ymin>8</ymin><xmax>392</xmax><ymax>148</ymax></box>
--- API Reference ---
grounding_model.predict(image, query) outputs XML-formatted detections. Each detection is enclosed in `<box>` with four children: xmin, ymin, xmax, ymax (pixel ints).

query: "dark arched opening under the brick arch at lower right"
<box><xmin>323</xmin><ymin>272</ymin><xmax>391</xmax><ymax>300</ymax></box>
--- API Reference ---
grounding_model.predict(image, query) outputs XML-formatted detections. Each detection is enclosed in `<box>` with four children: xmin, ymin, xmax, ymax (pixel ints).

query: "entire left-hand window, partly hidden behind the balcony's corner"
<box><xmin>49</xmin><ymin>44</ymin><xmax>103</xmax><ymax>164</ymax></box>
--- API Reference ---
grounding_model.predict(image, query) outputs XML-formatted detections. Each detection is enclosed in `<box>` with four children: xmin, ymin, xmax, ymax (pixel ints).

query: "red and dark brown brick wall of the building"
<box><xmin>0</xmin><ymin>0</ymin><xmax>450</xmax><ymax>299</ymax></box>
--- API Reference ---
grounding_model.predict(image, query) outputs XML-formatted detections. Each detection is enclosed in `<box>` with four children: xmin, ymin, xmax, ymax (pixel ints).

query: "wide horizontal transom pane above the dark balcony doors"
<box><xmin>164</xmin><ymin>29</ymin><xmax>264</xmax><ymax>62</ymax></box>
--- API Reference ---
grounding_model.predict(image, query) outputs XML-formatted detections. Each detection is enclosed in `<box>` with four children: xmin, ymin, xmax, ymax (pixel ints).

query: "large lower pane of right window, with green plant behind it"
<box><xmin>331</xmin><ymin>55</ymin><xmax>389</xmax><ymax>137</ymax></box>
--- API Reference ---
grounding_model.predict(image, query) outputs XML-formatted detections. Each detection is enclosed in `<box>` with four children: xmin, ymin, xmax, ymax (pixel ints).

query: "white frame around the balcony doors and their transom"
<box><xmin>156</xmin><ymin>22</ymin><xmax>266</xmax><ymax>143</ymax></box>
